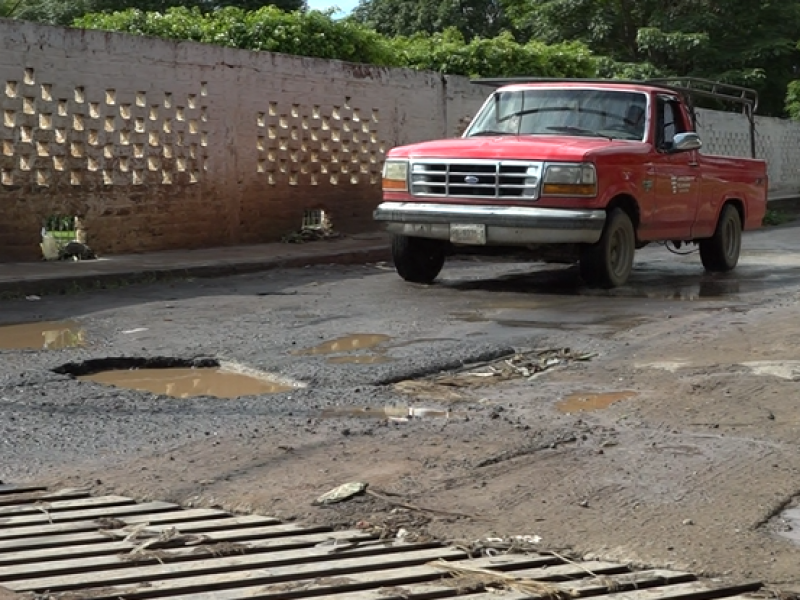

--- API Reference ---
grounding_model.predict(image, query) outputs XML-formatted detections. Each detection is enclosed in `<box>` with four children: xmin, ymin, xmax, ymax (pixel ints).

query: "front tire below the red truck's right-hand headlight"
<box><xmin>579</xmin><ymin>208</ymin><xmax>636</xmax><ymax>288</ymax></box>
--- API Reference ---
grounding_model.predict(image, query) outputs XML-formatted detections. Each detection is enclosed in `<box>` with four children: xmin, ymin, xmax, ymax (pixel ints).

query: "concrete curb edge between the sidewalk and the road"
<box><xmin>0</xmin><ymin>243</ymin><xmax>391</xmax><ymax>299</ymax></box>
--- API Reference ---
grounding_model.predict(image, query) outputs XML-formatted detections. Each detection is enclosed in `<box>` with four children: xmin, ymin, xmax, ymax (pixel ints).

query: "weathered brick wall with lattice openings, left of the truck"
<box><xmin>0</xmin><ymin>20</ymin><xmax>487</xmax><ymax>261</ymax></box>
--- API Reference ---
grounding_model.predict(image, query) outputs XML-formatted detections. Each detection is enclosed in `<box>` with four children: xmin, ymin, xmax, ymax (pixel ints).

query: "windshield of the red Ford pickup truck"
<box><xmin>464</xmin><ymin>88</ymin><xmax>647</xmax><ymax>141</ymax></box>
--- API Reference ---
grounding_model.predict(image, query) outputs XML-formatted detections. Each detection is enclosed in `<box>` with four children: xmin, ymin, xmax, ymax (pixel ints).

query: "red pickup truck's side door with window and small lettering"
<box><xmin>653</xmin><ymin>94</ymin><xmax>700</xmax><ymax>240</ymax></box>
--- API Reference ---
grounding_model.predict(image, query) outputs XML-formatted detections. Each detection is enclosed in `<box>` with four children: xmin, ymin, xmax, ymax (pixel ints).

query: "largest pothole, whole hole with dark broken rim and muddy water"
<box><xmin>54</xmin><ymin>357</ymin><xmax>305</xmax><ymax>399</ymax></box>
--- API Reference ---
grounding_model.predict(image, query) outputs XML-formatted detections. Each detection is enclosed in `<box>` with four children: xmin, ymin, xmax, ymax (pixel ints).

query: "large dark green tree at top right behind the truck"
<box><xmin>504</xmin><ymin>0</ymin><xmax>800</xmax><ymax>114</ymax></box>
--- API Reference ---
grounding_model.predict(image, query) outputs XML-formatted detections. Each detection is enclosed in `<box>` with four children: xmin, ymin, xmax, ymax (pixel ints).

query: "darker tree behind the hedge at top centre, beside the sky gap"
<box><xmin>349</xmin><ymin>0</ymin><xmax>509</xmax><ymax>41</ymax></box>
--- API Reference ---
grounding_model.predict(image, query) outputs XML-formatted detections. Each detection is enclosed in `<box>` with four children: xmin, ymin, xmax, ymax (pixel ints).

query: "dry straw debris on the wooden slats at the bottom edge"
<box><xmin>428</xmin><ymin>559</ymin><xmax>578</xmax><ymax>600</ymax></box>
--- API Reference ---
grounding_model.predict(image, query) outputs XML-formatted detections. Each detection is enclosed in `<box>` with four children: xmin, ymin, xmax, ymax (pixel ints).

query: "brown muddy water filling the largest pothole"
<box><xmin>77</xmin><ymin>367</ymin><xmax>296</xmax><ymax>398</ymax></box>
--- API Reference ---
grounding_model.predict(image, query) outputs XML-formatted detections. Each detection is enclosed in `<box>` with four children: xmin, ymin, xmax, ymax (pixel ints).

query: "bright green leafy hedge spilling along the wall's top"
<box><xmin>75</xmin><ymin>7</ymin><xmax>596</xmax><ymax>77</ymax></box>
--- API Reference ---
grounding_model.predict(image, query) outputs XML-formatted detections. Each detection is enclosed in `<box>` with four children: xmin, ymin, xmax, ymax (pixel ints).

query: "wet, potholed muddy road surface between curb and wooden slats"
<box><xmin>0</xmin><ymin>224</ymin><xmax>800</xmax><ymax>588</ymax></box>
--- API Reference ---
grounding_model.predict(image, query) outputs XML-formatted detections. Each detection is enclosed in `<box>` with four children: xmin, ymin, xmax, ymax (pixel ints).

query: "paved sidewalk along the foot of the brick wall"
<box><xmin>0</xmin><ymin>232</ymin><xmax>389</xmax><ymax>297</ymax></box>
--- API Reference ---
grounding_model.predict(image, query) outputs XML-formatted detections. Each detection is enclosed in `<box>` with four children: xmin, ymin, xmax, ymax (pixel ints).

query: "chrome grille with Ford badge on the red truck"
<box><xmin>411</xmin><ymin>160</ymin><xmax>542</xmax><ymax>200</ymax></box>
